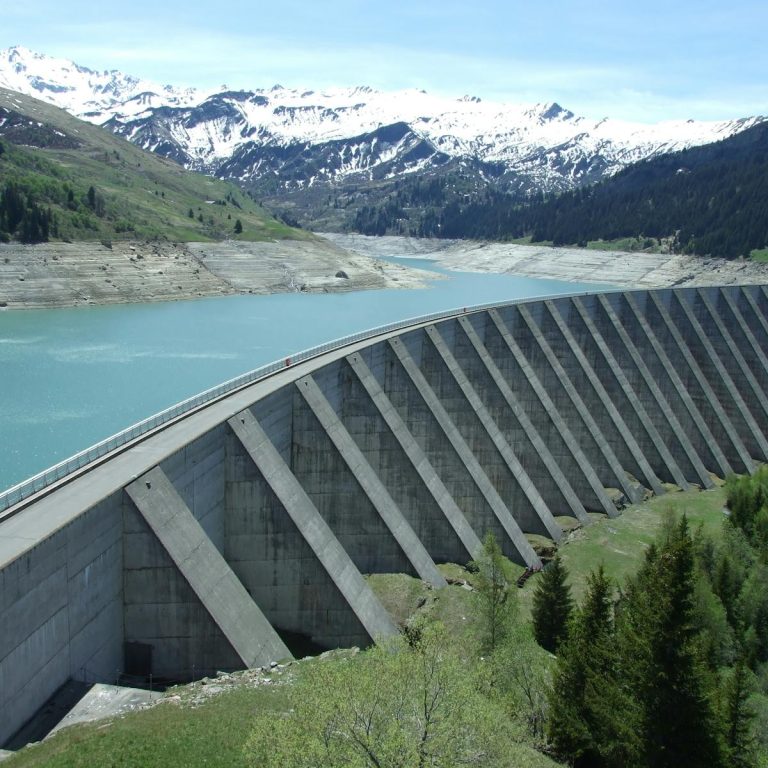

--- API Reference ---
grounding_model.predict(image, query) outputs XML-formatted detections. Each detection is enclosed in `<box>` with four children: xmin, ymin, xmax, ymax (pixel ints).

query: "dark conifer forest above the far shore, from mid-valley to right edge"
<box><xmin>354</xmin><ymin>124</ymin><xmax>768</xmax><ymax>258</ymax></box>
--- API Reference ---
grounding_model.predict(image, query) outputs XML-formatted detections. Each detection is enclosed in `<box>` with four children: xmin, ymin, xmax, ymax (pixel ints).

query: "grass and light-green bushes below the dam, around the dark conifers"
<box><xmin>7</xmin><ymin>486</ymin><xmax>768</xmax><ymax>768</ymax></box>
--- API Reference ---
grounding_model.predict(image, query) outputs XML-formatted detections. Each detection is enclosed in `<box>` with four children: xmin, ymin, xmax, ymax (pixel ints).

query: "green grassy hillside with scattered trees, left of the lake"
<box><xmin>0</xmin><ymin>88</ymin><xmax>311</xmax><ymax>242</ymax></box>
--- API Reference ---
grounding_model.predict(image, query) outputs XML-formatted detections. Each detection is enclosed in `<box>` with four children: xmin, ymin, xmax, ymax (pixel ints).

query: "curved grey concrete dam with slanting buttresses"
<box><xmin>0</xmin><ymin>286</ymin><xmax>768</xmax><ymax>744</ymax></box>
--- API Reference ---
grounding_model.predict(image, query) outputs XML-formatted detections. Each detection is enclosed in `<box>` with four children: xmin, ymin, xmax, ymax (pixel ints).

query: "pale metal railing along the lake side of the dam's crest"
<box><xmin>0</xmin><ymin>289</ymin><xmax>612</xmax><ymax>513</ymax></box>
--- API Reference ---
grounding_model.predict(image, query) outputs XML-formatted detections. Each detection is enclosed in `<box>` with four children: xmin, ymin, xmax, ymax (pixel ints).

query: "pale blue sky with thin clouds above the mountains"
<box><xmin>0</xmin><ymin>0</ymin><xmax>768</xmax><ymax>122</ymax></box>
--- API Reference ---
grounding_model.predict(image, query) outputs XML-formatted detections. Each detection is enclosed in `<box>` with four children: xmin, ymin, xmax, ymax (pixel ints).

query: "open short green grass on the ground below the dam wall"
<box><xmin>4</xmin><ymin>489</ymin><xmax>725</xmax><ymax>768</ymax></box>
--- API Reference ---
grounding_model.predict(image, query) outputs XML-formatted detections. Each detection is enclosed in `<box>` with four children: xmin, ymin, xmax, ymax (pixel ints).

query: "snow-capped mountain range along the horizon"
<box><xmin>0</xmin><ymin>47</ymin><xmax>764</xmax><ymax>206</ymax></box>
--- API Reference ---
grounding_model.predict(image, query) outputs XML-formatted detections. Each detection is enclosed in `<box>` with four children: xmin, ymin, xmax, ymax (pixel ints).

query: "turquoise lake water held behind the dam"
<box><xmin>0</xmin><ymin>252</ymin><xmax>606</xmax><ymax>491</ymax></box>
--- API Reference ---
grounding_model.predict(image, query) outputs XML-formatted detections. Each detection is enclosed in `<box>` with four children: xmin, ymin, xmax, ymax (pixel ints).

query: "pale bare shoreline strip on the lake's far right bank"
<box><xmin>323</xmin><ymin>234</ymin><xmax>768</xmax><ymax>288</ymax></box>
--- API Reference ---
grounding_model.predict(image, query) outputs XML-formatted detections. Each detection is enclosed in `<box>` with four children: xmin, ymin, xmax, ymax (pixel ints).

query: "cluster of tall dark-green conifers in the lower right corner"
<box><xmin>534</xmin><ymin>469</ymin><xmax>768</xmax><ymax>768</ymax></box>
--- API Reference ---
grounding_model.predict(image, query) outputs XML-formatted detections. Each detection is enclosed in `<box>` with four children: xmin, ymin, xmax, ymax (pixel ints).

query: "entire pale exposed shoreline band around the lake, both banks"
<box><xmin>0</xmin><ymin>234</ymin><xmax>768</xmax><ymax>310</ymax></box>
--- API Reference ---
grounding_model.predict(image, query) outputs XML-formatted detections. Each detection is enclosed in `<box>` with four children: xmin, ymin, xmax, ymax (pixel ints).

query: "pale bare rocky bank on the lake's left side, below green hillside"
<box><xmin>0</xmin><ymin>238</ymin><xmax>439</xmax><ymax>309</ymax></box>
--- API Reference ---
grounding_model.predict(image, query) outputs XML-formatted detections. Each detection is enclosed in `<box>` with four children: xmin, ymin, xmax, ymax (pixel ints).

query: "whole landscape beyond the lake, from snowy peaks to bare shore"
<box><xmin>0</xmin><ymin>48</ymin><xmax>768</xmax><ymax>309</ymax></box>
